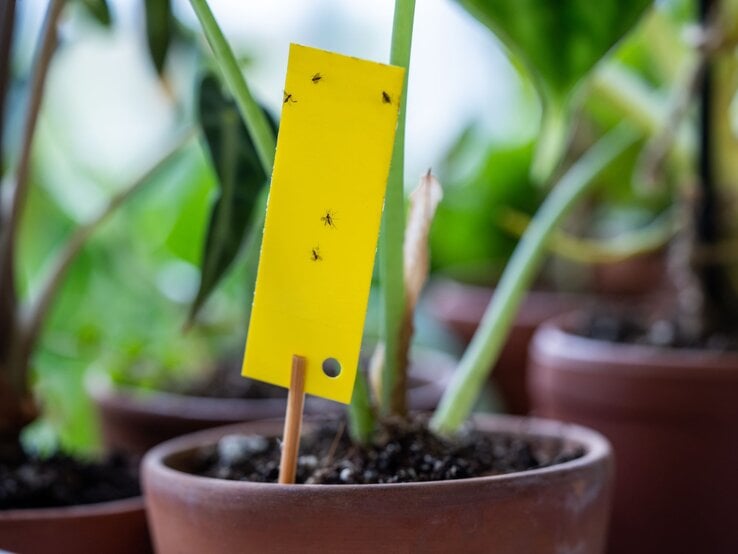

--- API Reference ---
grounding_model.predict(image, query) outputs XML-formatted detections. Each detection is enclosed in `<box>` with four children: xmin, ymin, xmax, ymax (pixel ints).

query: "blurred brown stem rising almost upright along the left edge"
<box><xmin>0</xmin><ymin>0</ymin><xmax>65</xmax><ymax>402</ymax></box>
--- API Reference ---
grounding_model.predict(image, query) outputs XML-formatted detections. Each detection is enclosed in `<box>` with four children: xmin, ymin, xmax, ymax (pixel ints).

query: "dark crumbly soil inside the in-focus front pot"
<box><xmin>189</xmin><ymin>419</ymin><xmax>584</xmax><ymax>484</ymax></box>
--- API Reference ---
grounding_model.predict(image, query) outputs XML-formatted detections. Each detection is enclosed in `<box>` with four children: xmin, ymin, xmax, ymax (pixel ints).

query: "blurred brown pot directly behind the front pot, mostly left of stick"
<box><xmin>89</xmin><ymin>350</ymin><xmax>456</xmax><ymax>454</ymax></box>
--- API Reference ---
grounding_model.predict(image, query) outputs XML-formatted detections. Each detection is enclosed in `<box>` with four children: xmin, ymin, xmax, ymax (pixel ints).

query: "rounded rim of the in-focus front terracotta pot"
<box><xmin>141</xmin><ymin>414</ymin><xmax>613</xmax><ymax>495</ymax></box>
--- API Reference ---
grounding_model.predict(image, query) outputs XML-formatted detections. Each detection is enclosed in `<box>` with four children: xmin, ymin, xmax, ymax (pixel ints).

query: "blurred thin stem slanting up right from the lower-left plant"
<box><xmin>11</xmin><ymin>131</ymin><xmax>196</xmax><ymax>388</ymax></box>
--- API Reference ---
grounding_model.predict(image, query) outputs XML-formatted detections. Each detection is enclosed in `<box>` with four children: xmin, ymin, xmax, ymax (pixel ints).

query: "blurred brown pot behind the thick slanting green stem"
<box><xmin>427</xmin><ymin>279</ymin><xmax>588</xmax><ymax>415</ymax></box>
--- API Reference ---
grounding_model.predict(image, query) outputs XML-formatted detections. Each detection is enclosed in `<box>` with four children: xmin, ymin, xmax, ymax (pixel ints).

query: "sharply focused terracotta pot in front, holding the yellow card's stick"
<box><xmin>143</xmin><ymin>416</ymin><xmax>612</xmax><ymax>554</ymax></box>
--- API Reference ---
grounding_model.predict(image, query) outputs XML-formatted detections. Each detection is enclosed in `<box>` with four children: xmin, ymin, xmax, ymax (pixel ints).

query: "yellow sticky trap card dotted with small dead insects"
<box><xmin>242</xmin><ymin>44</ymin><xmax>404</xmax><ymax>403</ymax></box>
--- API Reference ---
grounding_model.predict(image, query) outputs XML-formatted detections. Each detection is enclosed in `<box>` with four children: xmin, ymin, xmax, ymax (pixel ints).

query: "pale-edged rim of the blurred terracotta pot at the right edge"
<box><xmin>531</xmin><ymin>310</ymin><xmax>738</xmax><ymax>370</ymax></box>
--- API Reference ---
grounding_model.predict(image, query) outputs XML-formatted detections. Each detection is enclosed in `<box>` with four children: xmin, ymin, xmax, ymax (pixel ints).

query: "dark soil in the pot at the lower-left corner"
<box><xmin>0</xmin><ymin>448</ymin><xmax>141</xmax><ymax>510</ymax></box>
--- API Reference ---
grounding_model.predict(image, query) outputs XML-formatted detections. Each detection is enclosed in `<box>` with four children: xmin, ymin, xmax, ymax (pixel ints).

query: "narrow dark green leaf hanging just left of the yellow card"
<box><xmin>189</xmin><ymin>74</ymin><xmax>276</xmax><ymax>322</ymax></box>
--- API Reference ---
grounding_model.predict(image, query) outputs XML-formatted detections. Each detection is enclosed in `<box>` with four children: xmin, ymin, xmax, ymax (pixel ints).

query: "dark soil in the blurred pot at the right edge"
<box><xmin>574</xmin><ymin>312</ymin><xmax>738</xmax><ymax>352</ymax></box>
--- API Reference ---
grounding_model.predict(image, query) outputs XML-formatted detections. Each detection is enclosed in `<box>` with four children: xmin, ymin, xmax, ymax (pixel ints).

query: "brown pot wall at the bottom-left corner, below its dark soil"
<box><xmin>0</xmin><ymin>497</ymin><xmax>152</xmax><ymax>554</ymax></box>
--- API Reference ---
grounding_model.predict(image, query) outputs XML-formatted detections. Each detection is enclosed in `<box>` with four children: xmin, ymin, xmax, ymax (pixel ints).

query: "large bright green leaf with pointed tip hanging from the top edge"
<box><xmin>459</xmin><ymin>0</ymin><xmax>652</xmax><ymax>181</ymax></box>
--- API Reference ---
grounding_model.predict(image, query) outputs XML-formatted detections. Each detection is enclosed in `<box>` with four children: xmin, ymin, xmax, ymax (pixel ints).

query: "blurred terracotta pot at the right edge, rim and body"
<box><xmin>530</xmin><ymin>318</ymin><xmax>738</xmax><ymax>554</ymax></box>
